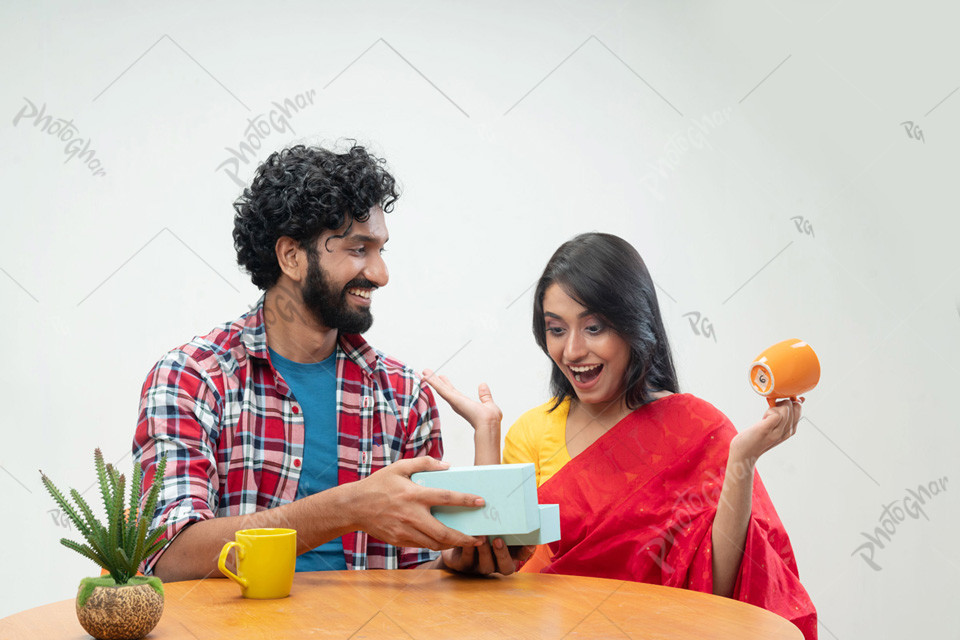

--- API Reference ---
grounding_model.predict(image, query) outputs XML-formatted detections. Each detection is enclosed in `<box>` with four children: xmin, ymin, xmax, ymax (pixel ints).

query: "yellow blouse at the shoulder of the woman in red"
<box><xmin>503</xmin><ymin>398</ymin><xmax>570</xmax><ymax>487</ymax></box>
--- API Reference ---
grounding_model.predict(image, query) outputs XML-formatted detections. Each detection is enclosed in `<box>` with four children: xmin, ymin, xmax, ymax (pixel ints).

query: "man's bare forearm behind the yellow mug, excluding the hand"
<box><xmin>154</xmin><ymin>483</ymin><xmax>357</xmax><ymax>582</ymax></box>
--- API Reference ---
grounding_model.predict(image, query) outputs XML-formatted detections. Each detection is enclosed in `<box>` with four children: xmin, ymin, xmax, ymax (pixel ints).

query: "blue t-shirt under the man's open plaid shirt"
<box><xmin>270</xmin><ymin>349</ymin><xmax>347</xmax><ymax>571</ymax></box>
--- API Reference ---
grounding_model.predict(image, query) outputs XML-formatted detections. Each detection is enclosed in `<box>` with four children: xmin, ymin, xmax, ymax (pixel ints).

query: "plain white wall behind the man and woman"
<box><xmin>0</xmin><ymin>0</ymin><xmax>960</xmax><ymax>639</ymax></box>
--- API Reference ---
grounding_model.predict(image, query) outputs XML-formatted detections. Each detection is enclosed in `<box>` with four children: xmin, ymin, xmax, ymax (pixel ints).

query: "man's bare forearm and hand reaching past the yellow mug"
<box><xmin>160</xmin><ymin>457</ymin><xmax>483</xmax><ymax>582</ymax></box>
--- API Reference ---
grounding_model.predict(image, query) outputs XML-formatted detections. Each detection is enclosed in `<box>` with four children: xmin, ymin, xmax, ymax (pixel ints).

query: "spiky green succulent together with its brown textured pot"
<box><xmin>40</xmin><ymin>449</ymin><xmax>167</xmax><ymax>640</ymax></box>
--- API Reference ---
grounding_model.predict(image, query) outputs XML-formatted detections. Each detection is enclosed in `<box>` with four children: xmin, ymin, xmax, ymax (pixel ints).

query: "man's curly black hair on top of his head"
<box><xmin>233</xmin><ymin>144</ymin><xmax>400</xmax><ymax>290</ymax></box>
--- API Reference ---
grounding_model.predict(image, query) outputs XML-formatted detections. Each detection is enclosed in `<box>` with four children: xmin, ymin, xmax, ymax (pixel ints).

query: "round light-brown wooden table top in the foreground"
<box><xmin>0</xmin><ymin>570</ymin><xmax>802</xmax><ymax>640</ymax></box>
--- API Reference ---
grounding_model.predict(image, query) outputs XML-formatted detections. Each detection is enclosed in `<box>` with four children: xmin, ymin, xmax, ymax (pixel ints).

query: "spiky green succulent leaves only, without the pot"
<box><xmin>40</xmin><ymin>449</ymin><xmax>167</xmax><ymax>592</ymax></box>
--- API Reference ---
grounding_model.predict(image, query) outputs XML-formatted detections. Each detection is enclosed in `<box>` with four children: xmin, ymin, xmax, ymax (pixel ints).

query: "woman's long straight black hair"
<box><xmin>533</xmin><ymin>233</ymin><xmax>679</xmax><ymax>411</ymax></box>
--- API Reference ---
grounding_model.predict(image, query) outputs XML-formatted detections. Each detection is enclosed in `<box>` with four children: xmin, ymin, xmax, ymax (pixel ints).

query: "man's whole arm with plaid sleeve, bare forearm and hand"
<box><xmin>134</xmin><ymin>350</ymin><xmax>482</xmax><ymax>580</ymax></box>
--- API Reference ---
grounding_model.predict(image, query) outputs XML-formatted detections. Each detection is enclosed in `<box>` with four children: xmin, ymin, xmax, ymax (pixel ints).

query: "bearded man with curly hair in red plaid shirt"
<box><xmin>133</xmin><ymin>146</ymin><xmax>530</xmax><ymax>581</ymax></box>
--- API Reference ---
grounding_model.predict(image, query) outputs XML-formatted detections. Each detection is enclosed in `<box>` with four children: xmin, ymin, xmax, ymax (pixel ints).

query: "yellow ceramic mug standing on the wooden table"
<box><xmin>218</xmin><ymin>529</ymin><xmax>297</xmax><ymax>600</ymax></box>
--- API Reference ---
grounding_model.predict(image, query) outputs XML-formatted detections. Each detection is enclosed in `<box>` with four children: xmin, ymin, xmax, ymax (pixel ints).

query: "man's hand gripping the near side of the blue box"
<box><xmin>344</xmin><ymin>456</ymin><xmax>484</xmax><ymax>551</ymax></box>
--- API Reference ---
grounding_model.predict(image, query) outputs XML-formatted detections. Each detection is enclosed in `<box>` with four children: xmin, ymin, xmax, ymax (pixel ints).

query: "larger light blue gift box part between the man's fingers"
<box><xmin>410</xmin><ymin>462</ymin><xmax>544</xmax><ymax>536</ymax></box>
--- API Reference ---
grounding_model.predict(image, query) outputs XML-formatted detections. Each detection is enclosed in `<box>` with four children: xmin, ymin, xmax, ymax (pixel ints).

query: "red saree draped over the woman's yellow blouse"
<box><xmin>525</xmin><ymin>394</ymin><xmax>817</xmax><ymax>640</ymax></box>
